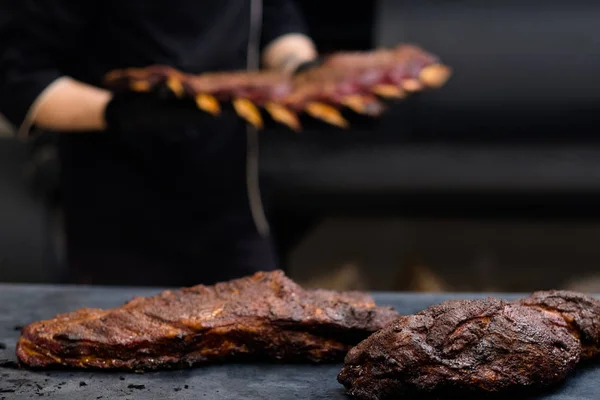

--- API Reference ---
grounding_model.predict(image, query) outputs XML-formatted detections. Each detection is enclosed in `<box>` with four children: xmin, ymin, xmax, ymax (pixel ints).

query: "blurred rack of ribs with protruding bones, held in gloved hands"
<box><xmin>105</xmin><ymin>44</ymin><xmax>451</xmax><ymax>131</ymax></box>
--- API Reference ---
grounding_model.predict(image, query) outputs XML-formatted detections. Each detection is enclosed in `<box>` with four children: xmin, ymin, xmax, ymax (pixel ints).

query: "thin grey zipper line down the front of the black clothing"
<box><xmin>246</xmin><ymin>0</ymin><xmax>270</xmax><ymax>237</ymax></box>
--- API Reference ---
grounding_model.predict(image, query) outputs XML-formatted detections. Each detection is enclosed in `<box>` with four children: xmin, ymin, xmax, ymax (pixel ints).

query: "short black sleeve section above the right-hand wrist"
<box><xmin>261</xmin><ymin>0</ymin><xmax>308</xmax><ymax>49</ymax></box>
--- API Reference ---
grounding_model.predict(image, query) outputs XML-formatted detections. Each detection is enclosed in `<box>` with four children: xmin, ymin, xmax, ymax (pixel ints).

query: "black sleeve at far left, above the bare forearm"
<box><xmin>0</xmin><ymin>0</ymin><xmax>94</xmax><ymax>134</ymax></box>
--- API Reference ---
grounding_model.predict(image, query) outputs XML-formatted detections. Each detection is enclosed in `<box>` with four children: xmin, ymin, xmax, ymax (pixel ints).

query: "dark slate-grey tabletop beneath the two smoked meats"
<box><xmin>0</xmin><ymin>285</ymin><xmax>600</xmax><ymax>400</ymax></box>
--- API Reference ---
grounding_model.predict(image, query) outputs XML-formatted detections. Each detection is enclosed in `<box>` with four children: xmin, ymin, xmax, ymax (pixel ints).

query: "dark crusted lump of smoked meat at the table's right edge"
<box><xmin>338</xmin><ymin>291</ymin><xmax>600</xmax><ymax>400</ymax></box>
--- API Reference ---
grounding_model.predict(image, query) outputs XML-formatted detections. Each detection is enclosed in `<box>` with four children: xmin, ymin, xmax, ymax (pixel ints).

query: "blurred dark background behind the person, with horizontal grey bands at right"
<box><xmin>0</xmin><ymin>0</ymin><xmax>600</xmax><ymax>293</ymax></box>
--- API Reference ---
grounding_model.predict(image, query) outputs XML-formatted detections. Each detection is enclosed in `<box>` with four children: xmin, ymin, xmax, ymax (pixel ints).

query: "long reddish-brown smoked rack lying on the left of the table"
<box><xmin>17</xmin><ymin>271</ymin><xmax>398</xmax><ymax>371</ymax></box>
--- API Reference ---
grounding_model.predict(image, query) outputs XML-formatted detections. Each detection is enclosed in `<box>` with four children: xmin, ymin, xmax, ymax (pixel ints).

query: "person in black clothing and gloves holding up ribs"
<box><xmin>0</xmin><ymin>0</ymin><xmax>318</xmax><ymax>286</ymax></box>
